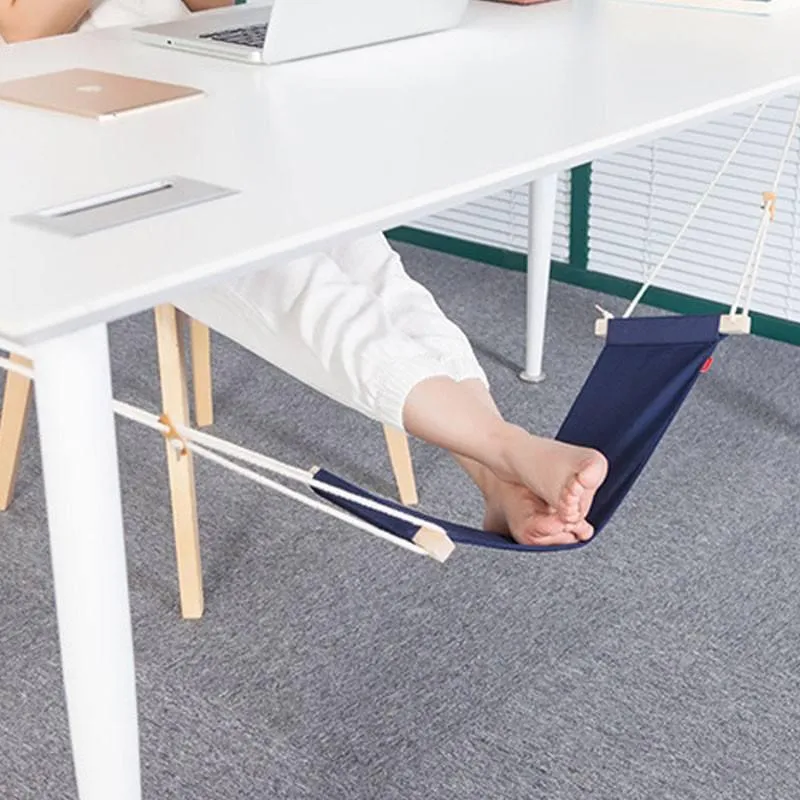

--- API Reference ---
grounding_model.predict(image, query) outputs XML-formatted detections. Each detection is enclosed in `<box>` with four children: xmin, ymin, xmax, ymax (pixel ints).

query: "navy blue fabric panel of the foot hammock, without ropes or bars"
<box><xmin>315</xmin><ymin>316</ymin><xmax>724</xmax><ymax>552</ymax></box>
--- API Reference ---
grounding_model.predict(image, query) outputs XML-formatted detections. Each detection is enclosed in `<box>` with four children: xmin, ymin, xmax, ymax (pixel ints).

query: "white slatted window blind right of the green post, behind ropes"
<box><xmin>589</xmin><ymin>96</ymin><xmax>800</xmax><ymax>321</ymax></box>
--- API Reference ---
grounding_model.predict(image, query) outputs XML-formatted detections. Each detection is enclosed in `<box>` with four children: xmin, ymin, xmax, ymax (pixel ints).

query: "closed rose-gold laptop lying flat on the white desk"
<box><xmin>0</xmin><ymin>69</ymin><xmax>203</xmax><ymax>119</ymax></box>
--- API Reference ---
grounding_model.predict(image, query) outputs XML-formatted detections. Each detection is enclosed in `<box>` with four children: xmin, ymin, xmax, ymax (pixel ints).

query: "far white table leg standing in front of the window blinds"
<box><xmin>520</xmin><ymin>173</ymin><xmax>558</xmax><ymax>383</ymax></box>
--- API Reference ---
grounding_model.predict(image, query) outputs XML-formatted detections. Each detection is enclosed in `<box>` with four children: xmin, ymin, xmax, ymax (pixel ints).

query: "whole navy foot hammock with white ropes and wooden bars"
<box><xmin>111</xmin><ymin>102</ymin><xmax>780</xmax><ymax>561</ymax></box>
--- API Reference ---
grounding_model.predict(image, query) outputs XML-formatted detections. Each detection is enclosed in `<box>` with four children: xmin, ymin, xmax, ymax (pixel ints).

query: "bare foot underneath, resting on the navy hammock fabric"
<box><xmin>479</xmin><ymin>470</ymin><xmax>594</xmax><ymax>545</ymax></box>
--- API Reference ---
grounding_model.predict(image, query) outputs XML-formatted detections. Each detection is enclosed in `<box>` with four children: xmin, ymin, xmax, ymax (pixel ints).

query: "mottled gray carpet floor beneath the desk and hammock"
<box><xmin>0</xmin><ymin>247</ymin><xmax>800</xmax><ymax>800</ymax></box>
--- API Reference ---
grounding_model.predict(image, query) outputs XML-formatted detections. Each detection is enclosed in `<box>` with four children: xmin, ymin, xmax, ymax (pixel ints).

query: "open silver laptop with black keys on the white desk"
<box><xmin>135</xmin><ymin>0</ymin><xmax>469</xmax><ymax>64</ymax></box>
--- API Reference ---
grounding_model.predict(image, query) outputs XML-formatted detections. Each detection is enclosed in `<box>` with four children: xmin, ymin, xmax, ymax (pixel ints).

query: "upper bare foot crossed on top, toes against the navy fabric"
<box><xmin>487</xmin><ymin>425</ymin><xmax>608</xmax><ymax>524</ymax></box>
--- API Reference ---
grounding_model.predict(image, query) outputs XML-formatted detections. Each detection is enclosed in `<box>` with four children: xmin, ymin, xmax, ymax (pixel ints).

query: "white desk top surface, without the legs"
<box><xmin>0</xmin><ymin>0</ymin><xmax>800</xmax><ymax>345</ymax></box>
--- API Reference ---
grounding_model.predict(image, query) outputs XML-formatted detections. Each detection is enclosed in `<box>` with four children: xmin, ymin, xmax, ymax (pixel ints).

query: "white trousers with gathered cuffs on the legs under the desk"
<box><xmin>174</xmin><ymin>237</ymin><xmax>485</xmax><ymax>429</ymax></box>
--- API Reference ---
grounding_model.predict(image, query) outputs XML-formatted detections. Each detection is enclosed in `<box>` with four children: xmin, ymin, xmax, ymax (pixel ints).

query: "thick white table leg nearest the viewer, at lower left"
<box><xmin>31</xmin><ymin>325</ymin><xmax>141</xmax><ymax>800</ymax></box>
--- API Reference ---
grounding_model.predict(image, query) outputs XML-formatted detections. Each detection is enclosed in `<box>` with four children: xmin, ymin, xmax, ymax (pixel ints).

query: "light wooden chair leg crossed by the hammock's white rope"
<box><xmin>155</xmin><ymin>305</ymin><xmax>203</xmax><ymax>619</ymax></box>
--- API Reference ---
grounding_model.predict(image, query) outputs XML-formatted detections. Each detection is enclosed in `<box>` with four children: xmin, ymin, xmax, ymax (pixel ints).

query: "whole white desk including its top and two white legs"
<box><xmin>0</xmin><ymin>0</ymin><xmax>800</xmax><ymax>800</ymax></box>
